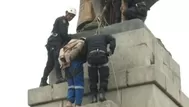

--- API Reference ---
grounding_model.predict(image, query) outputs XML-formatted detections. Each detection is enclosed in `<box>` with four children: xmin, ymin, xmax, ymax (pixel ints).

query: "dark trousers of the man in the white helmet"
<box><xmin>43</xmin><ymin>48</ymin><xmax>62</xmax><ymax>80</ymax></box>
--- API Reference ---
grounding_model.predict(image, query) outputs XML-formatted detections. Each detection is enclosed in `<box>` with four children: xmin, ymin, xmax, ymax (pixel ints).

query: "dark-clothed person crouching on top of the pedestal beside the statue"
<box><xmin>121</xmin><ymin>0</ymin><xmax>148</xmax><ymax>22</ymax></box>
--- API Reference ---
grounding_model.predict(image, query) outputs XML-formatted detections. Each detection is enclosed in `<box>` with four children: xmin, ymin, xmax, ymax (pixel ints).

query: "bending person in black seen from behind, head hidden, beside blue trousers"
<box><xmin>85</xmin><ymin>35</ymin><xmax>116</xmax><ymax>103</ymax></box>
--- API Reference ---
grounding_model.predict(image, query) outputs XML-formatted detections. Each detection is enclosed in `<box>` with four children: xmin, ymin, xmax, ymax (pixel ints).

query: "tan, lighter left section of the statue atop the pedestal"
<box><xmin>77</xmin><ymin>0</ymin><xmax>104</xmax><ymax>32</ymax></box>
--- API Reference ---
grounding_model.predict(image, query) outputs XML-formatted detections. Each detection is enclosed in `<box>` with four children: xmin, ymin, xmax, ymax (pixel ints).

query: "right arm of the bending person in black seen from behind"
<box><xmin>106</xmin><ymin>35</ymin><xmax>116</xmax><ymax>54</ymax></box>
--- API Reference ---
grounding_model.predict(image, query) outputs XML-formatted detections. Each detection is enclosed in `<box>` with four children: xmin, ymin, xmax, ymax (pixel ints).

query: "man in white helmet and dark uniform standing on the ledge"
<box><xmin>40</xmin><ymin>8</ymin><xmax>76</xmax><ymax>87</ymax></box>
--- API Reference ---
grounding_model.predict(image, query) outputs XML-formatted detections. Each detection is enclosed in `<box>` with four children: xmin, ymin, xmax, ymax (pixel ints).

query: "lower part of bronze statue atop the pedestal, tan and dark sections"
<box><xmin>77</xmin><ymin>0</ymin><xmax>125</xmax><ymax>32</ymax></box>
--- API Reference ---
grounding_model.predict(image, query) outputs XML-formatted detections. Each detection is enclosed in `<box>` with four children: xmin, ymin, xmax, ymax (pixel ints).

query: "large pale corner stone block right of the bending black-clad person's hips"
<box><xmin>110</xmin><ymin>44</ymin><xmax>153</xmax><ymax>72</ymax></box>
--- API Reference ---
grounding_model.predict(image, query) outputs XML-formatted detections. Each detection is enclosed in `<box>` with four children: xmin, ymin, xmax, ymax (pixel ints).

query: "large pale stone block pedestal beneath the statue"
<box><xmin>28</xmin><ymin>19</ymin><xmax>189</xmax><ymax>107</ymax></box>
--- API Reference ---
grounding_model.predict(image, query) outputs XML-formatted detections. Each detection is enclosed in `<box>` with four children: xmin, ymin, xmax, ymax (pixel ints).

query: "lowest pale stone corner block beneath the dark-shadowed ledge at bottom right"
<box><xmin>122</xmin><ymin>84</ymin><xmax>179</xmax><ymax>107</ymax></box>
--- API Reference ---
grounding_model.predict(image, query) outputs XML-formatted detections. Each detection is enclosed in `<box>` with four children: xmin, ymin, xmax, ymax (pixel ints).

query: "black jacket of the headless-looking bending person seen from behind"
<box><xmin>86</xmin><ymin>35</ymin><xmax>116</xmax><ymax>54</ymax></box>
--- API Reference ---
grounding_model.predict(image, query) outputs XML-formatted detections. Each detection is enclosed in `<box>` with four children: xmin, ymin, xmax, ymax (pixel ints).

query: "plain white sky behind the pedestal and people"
<box><xmin>0</xmin><ymin>0</ymin><xmax>189</xmax><ymax>107</ymax></box>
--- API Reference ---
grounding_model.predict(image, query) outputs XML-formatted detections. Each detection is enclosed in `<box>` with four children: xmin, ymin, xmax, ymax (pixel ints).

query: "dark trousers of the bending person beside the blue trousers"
<box><xmin>88</xmin><ymin>53</ymin><xmax>109</xmax><ymax>94</ymax></box>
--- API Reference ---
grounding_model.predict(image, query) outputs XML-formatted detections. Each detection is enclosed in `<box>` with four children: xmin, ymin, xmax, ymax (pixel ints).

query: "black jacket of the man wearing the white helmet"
<box><xmin>47</xmin><ymin>16</ymin><xmax>71</xmax><ymax>48</ymax></box>
